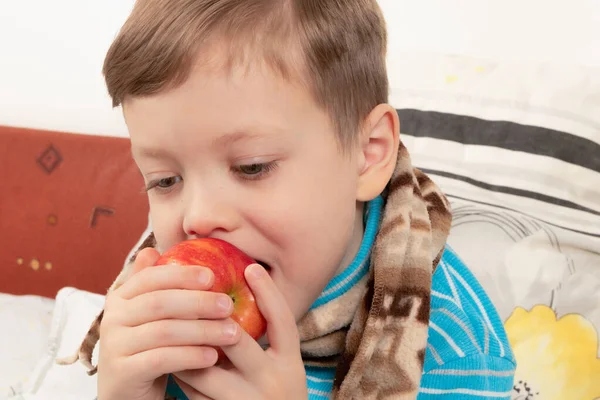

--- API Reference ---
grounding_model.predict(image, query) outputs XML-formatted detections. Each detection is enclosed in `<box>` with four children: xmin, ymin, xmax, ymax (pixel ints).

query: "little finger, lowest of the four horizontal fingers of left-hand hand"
<box><xmin>125</xmin><ymin>346</ymin><xmax>217</xmax><ymax>381</ymax></box>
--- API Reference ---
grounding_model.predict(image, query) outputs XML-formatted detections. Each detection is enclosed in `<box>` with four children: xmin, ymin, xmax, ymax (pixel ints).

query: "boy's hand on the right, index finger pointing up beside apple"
<box><xmin>174</xmin><ymin>265</ymin><xmax>308</xmax><ymax>400</ymax></box>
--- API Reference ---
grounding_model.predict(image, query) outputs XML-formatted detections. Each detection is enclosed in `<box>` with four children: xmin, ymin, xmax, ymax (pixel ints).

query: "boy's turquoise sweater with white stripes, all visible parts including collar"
<box><xmin>168</xmin><ymin>197</ymin><xmax>516</xmax><ymax>400</ymax></box>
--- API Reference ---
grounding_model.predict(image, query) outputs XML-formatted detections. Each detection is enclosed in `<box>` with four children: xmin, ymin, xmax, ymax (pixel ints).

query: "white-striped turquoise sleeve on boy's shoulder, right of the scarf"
<box><xmin>420</xmin><ymin>246</ymin><xmax>515</xmax><ymax>398</ymax></box>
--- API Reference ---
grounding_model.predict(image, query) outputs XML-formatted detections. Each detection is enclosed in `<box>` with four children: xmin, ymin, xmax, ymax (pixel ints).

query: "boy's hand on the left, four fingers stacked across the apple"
<box><xmin>98</xmin><ymin>249</ymin><xmax>240</xmax><ymax>400</ymax></box>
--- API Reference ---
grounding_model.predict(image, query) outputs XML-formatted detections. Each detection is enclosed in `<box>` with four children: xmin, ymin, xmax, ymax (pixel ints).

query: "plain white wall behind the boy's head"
<box><xmin>0</xmin><ymin>0</ymin><xmax>600</xmax><ymax>136</ymax></box>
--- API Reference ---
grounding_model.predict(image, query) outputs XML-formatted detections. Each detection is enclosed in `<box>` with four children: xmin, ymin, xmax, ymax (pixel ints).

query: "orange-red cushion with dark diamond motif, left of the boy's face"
<box><xmin>0</xmin><ymin>126</ymin><xmax>148</xmax><ymax>297</ymax></box>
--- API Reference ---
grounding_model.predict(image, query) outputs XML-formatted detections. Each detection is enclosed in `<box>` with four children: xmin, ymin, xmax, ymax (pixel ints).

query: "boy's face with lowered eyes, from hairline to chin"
<box><xmin>124</xmin><ymin>60</ymin><xmax>363</xmax><ymax>319</ymax></box>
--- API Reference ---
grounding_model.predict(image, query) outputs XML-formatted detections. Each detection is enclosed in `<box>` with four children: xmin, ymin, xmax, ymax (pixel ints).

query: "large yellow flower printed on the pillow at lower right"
<box><xmin>505</xmin><ymin>305</ymin><xmax>600</xmax><ymax>400</ymax></box>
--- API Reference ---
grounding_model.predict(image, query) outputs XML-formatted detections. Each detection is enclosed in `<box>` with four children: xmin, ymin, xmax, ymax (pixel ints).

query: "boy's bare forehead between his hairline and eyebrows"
<box><xmin>123</xmin><ymin>43</ymin><xmax>338</xmax><ymax>158</ymax></box>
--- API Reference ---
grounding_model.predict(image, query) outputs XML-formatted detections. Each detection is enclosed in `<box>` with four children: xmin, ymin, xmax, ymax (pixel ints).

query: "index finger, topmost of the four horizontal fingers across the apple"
<box><xmin>118</xmin><ymin>262</ymin><xmax>214</xmax><ymax>300</ymax></box>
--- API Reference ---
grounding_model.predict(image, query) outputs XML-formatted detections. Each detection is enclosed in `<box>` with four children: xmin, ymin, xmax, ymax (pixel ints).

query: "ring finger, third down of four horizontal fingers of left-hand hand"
<box><xmin>122</xmin><ymin>319</ymin><xmax>240</xmax><ymax>355</ymax></box>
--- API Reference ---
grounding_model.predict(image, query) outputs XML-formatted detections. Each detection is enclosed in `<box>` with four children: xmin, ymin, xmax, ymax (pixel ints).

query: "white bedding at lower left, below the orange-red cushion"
<box><xmin>0</xmin><ymin>287</ymin><xmax>104</xmax><ymax>400</ymax></box>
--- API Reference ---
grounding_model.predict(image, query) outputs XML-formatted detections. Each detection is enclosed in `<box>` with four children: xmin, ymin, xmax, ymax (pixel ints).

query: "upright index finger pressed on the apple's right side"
<box><xmin>245</xmin><ymin>264</ymin><xmax>300</xmax><ymax>356</ymax></box>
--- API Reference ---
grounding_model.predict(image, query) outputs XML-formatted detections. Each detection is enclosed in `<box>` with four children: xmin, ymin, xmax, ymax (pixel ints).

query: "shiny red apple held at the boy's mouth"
<box><xmin>155</xmin><ymin>238</ymin><xmax>267</xmax><ymax>360</ymax></box>
